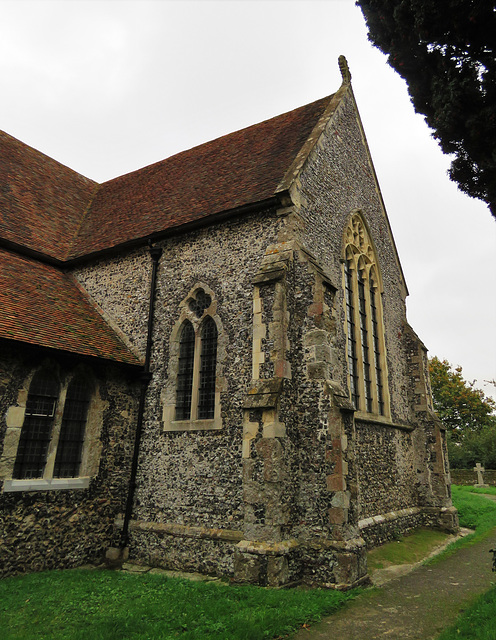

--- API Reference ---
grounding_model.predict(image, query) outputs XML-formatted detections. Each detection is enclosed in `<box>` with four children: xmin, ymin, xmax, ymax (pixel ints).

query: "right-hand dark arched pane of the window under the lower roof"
<box><xmin>53</xmin><ymin>378</ymin><xmax>91</xmax><ymax>478</ymax></box>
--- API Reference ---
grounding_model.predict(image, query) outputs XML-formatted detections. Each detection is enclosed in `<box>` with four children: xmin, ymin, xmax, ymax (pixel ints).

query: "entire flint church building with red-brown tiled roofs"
<box><xmin>0</xmin><ymin>58</ymin><xmax>458</xmax><ymax>589</ymax></box>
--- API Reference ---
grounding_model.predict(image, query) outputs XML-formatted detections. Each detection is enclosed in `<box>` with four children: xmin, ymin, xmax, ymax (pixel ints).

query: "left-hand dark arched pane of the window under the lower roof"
<box><xmin>14</xmin><ymin>371</ymin><xmax>59</xmax><ymax>478</ymax></box>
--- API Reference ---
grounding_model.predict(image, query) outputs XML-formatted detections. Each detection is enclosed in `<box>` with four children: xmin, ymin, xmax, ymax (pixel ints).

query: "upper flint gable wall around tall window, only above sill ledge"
<box><xmin>291</xmin><ymin>87</ymin><xmax>412</xmax><ymax>423</ymax></box>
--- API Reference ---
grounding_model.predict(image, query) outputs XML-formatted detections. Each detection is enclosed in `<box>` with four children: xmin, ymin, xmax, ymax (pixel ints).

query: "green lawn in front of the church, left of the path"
<box><xmin>0</xmin><ymin>570</ymin><xmax>356</xmax><ymax>640</ymax></box>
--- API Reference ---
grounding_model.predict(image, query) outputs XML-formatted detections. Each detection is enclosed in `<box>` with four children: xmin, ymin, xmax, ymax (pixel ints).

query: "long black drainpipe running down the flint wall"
<box><xmin>120</xmin><ymin>240</ymin><xmax>162</xmax><ymax>549</ymax></box>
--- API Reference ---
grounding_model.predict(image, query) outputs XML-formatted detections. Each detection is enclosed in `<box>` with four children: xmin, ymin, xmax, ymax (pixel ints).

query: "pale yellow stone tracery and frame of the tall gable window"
<box><xmin>342</xmin><ymin>210</ymin><xmax>391</xmax><ymax>422</ymax></box>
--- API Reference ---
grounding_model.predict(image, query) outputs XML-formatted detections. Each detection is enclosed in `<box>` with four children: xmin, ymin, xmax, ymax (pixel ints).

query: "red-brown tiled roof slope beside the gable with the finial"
<box><xmin>68</xmin><ymin>97</ymin><xmax>330</xmax><ymax>257</ymax></box>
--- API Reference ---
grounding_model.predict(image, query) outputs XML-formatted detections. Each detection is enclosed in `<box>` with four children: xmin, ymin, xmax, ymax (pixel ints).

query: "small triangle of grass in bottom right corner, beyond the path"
<box><xmin>438</xmin><ymin>586</ymin><xmax>496</xmax><ymax>640</ymax></box>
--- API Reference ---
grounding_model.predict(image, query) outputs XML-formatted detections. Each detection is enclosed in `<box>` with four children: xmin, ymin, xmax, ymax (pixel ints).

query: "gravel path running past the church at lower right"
<box><xmin>292</xmin><ymin>529</ymin><xmax>496</xmax><ymax>640</ymax></box>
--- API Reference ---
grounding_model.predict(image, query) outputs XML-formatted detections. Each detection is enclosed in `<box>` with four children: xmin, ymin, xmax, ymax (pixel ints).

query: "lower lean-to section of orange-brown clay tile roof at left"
<box><xmin>0</xmin><ymin>249</ymin><xmax>141</xmax><ymax>365</ymax></box>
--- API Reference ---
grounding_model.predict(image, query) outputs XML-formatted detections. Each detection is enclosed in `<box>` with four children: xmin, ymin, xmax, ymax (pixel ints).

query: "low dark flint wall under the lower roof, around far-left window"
<box><xmin>0</xmin><ymin>345</ymin><xmax>137</xmax><ymax>576</ymax></box>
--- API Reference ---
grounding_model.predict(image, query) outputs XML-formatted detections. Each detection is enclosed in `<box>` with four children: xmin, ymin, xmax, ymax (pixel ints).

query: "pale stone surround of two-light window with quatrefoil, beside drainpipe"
<box><xmin>162</xmin><ymin>282</ymin><xmax>227</xmax><ymax>431</ymax></box>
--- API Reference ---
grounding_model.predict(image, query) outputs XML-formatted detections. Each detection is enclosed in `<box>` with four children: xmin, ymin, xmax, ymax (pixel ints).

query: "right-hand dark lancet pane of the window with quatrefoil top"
<box><xmin>198</xmin><ymin>316</ymin><xmax>217</xmax><ymax>420</ymax></box>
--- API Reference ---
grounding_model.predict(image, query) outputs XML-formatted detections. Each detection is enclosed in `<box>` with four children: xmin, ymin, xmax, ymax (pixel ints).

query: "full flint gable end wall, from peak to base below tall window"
<box><xmin>290</xmin><ymin>82</ymin><xmax>454</xmax><ymax>533</ymax></box>
